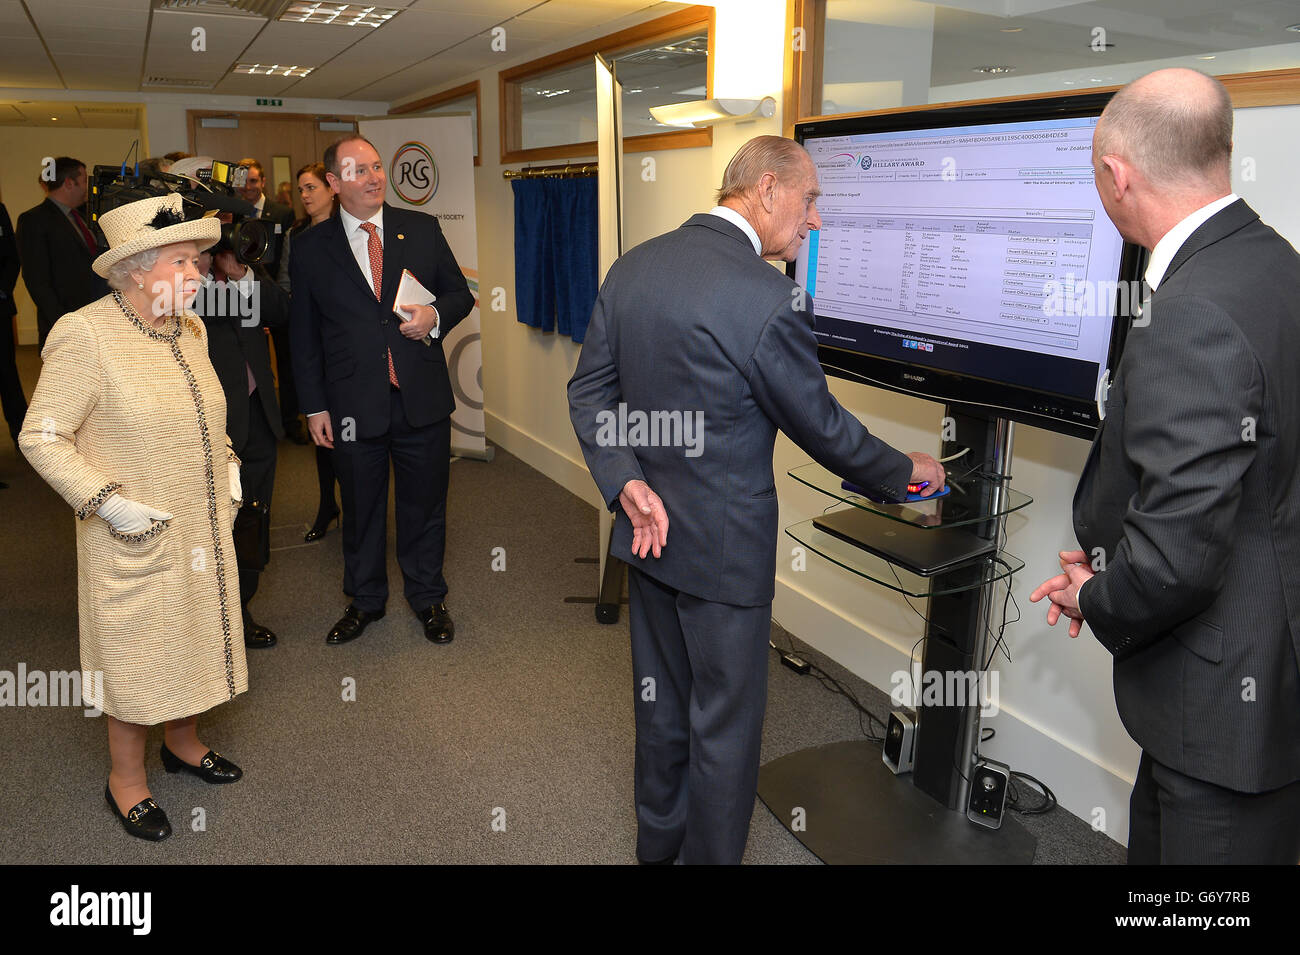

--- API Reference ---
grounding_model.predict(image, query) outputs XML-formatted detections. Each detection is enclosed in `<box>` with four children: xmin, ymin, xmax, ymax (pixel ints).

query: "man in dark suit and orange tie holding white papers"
<box><xmin>289</xmin><ymin>135</ymin><xmax>473</xmax><ymax>644</ymax></box>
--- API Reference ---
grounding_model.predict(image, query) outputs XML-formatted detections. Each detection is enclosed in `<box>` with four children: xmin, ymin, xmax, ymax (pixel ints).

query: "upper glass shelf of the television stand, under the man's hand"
<box><xmin>787</xmin><ymin>464</ymin><xmax>1034</xmax><ymax>530</ymax></box>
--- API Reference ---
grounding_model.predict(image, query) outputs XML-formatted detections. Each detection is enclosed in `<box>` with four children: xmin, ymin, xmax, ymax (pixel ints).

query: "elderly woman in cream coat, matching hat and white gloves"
<box><xmin>18</xmin><ymin>195</ymin><xmax>248</xmax><ymax>841</ymax></box>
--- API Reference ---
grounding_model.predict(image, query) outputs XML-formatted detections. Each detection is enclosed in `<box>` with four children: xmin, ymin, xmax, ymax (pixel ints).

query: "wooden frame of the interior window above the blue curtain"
<box><xmin>497</xmin><ymin>5</ymin><xmax>715</xmax><ymax>165</ymax></box>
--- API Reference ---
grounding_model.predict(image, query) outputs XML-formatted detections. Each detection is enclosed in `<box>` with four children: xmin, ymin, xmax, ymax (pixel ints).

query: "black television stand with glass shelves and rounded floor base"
<box><xmin>758</xmin><ymin>407</ymin><xmax>1036</xmax><ymax>864</ymax></box>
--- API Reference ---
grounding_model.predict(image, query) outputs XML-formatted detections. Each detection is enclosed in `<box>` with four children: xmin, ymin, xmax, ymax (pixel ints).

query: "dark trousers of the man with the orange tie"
<box><xmin>333</xmin><ymin>388</ymin><xmax>451</xmax><ymax>613</ymax></box>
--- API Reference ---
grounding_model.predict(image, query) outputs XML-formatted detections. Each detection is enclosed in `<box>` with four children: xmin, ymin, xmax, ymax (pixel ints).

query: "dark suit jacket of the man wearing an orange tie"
<box><xmin>289</xmin><ymin>204</ymin><xmax>475</xmax><ymax>439</ymax></box>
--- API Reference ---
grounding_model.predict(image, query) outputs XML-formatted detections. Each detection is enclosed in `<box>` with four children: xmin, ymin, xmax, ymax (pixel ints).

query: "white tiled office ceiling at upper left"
<box><xmin>0</xmin><ymin>0</ymin><xmax>685</xmax><ymax>116</ymax></box>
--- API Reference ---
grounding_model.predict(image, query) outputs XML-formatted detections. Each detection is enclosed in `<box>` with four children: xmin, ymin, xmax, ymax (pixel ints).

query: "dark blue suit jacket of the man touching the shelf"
<box><xmin>568</xmin><ymin>213</ymin><xmax>911</xmax><ymax>607</ymax></box>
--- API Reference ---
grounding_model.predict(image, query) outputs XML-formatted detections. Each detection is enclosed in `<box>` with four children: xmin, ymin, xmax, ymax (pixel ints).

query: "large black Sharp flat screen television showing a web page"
<box><xmin>789</xmin><ymin>94</ymin><xmax>1145</xmax><ymax>438</ymax></box>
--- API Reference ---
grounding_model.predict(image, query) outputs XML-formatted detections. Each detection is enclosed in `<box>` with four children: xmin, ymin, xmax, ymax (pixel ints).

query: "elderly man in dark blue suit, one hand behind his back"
<box><xmin>568</xmin><ymin>136</ymin><xmax>944</xmax><ymax>864</ymax></box>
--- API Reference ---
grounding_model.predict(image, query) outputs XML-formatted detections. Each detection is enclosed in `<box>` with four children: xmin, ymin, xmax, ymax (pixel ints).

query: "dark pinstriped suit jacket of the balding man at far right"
<box><xmin>1074</xmin><ymin>201</ymin><xmax>1300</xmax><ymax>791</ymax></box>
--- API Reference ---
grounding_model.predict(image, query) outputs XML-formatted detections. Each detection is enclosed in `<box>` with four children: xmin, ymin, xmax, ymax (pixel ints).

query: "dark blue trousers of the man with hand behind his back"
<box><xmin>628</xmin><ymin>568</ymin><xmax>772</xmax><ymax>864</ymax></box>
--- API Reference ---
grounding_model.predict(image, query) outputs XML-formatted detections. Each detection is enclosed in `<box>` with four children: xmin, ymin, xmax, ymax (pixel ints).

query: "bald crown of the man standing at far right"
<box><xmin>1093</xmin><ymin>68</ymin><xmax>1232</xmax><ymax>190</ymax></box>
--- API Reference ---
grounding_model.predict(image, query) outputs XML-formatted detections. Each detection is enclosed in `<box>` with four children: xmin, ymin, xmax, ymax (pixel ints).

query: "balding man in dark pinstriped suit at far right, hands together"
<box><xmin>1031</xmin><ymin>69</ymin><xmax>1300</xmax><ymax>865</ymax></box>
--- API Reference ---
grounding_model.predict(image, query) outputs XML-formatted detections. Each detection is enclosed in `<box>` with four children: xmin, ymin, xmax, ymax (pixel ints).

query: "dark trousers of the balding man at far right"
<box><xmin>1128</xmin><ymin>751</ymin><xmax>1300</xmax><ymax>865</ymax></box>
